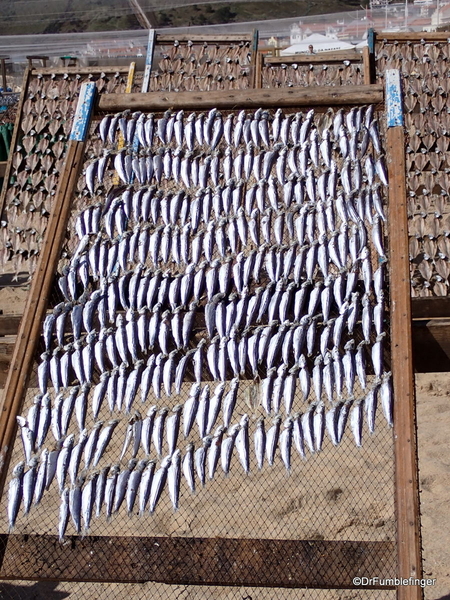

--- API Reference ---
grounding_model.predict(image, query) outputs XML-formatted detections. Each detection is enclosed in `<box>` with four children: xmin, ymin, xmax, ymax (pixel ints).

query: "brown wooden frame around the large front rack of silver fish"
<box><xmin>0</xmin><ymin>76</ymin><xmax>421</xmax><ymax>600</ymax></box>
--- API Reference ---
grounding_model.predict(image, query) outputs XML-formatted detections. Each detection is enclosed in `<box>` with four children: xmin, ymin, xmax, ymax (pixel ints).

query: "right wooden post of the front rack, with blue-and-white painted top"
<box><xmin>385</xmin><ymin>69</ymin><xmax>422</xmax><ymax>600</ymax></box>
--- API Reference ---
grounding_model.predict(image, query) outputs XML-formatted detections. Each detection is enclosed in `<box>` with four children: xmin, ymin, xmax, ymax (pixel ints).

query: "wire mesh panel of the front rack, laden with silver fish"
<box><xmin>1</xmin><ymin>107</ymin><xmax>395</xmax><ymax>598</ymax></box>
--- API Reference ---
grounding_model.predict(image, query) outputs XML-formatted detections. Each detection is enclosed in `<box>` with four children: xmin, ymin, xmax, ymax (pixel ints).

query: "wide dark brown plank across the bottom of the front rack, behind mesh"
<box><xmin>0</xmin><ymin>535</ymin><xmax>395</xmax><ymax>589</ymax></box>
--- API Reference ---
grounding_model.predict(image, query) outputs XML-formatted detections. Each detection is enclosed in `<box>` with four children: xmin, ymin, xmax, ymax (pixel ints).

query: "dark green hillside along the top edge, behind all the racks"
<box><xmin>0</xmin><ymin>0</ymin><xmax>368</xmax><ymax>35</ymax></box>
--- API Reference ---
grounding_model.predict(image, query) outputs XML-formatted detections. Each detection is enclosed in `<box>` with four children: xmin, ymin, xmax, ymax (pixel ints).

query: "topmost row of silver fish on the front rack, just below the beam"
<box><xmin>99</xmin><ymin>107</ymin><xmax>381</xmax><ymax>156</ymax></box>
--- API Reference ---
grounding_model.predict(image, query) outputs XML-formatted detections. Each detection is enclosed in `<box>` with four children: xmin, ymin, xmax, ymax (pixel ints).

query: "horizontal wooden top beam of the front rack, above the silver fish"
<box><xmin>97</xmin><ymin>85</ymin><xmax>383</xmax><ymax>112</ymax></box>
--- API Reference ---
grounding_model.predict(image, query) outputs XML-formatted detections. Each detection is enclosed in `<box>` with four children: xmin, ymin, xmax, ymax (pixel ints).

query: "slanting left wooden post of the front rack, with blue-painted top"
<box><xmin>0</xmin><ymin>83</ymin><xmax>96</xmax><ymax>496</ymax></box>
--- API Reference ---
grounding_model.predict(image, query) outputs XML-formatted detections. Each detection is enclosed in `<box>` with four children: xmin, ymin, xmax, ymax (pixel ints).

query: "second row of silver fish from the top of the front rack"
<box><xmin>86</xmin><ymin>148</ymin><xmax>387</xmax><ymax>200</ymax></box>
